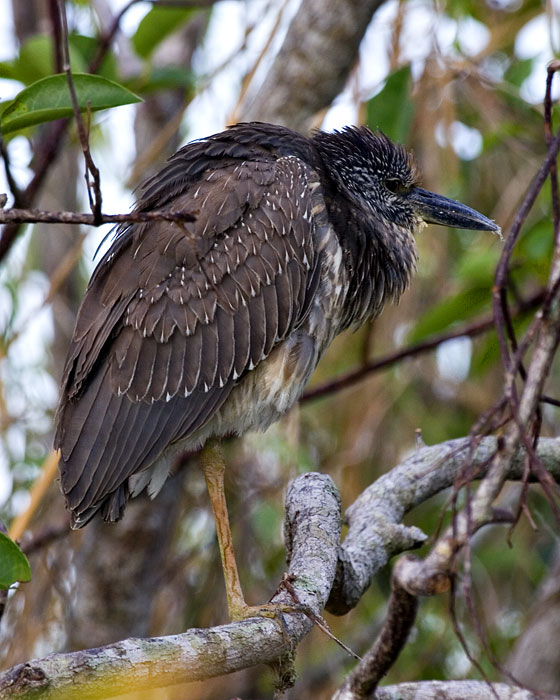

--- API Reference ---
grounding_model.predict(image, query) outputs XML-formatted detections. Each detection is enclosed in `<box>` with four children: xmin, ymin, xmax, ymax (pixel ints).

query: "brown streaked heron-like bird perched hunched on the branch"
<box><xmin>55</xmin><ymin>122</ymin><xmax>499</xmax><ymax>619</ymax></box>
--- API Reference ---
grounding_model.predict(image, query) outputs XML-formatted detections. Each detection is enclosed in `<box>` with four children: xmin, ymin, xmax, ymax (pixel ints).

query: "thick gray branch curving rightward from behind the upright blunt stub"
<box><xmin>327</xmin><ymin>437</ymin><xmax>560</xmax><ymax>615</ymax></box>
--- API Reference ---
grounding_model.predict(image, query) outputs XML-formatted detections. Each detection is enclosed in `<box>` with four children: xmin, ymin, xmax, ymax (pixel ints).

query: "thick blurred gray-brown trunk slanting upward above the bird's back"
<box><xmin>241</xmin><ymin>0</ymin><xmax>382</xmax><ymax>132</ymax></box>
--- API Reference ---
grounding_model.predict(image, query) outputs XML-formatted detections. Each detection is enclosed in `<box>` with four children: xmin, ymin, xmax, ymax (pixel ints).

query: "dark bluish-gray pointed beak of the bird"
<box><xmin>408</xmin><ymin>187</ymin><xmax>501</xmax><ymax>235</ymax></box>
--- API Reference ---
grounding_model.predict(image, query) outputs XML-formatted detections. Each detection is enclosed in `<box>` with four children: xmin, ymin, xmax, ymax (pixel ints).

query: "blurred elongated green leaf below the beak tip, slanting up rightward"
<box><xmin>408</xmin><ymin>285</ymin><xmax>491</xmax><ymax>343</ymax></box>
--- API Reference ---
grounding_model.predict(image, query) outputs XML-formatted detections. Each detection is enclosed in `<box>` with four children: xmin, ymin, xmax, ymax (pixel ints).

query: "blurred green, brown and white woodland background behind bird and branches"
<box><xmin>0</xmin><ymin>0</ymin><xmax>560</xmax><ymax>700</ymax></box>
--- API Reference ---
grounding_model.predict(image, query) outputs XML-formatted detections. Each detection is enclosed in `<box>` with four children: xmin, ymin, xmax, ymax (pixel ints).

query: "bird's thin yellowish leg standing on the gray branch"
<box><xmin>201</xmin><ymin>442</ymin><xmax>248</xmax><ymax>621</ymax></box>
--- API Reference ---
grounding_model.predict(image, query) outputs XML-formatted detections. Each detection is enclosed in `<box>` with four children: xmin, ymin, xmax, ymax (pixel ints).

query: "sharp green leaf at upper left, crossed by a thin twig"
<box><xmin>0</xmin><ymin>73</ymin><xmax>142</xmax><ymax>135</ymax></box>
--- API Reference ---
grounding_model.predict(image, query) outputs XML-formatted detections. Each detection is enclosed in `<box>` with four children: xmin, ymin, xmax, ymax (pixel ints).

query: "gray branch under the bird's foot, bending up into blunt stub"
<box><xmin>0</xmin><ymin>473</ymin><xmax>341</xmax><ymax>700</ymax></box>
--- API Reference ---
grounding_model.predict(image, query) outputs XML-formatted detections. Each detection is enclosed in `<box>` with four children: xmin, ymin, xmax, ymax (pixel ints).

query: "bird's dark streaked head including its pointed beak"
<box><xmin>314</xmin><ymin>126</ymin><xmax>500</xmax><ymax>242</ymax></box>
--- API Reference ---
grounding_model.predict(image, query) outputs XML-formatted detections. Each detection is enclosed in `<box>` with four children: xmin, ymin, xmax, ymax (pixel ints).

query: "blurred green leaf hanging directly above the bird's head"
<box><xmin>366</xmin><ymin>66</ymin><xmax>414</xmax><ymax>143</ymax></box>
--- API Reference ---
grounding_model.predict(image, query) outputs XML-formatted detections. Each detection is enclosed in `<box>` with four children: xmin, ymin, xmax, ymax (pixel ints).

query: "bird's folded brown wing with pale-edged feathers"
<box><xmin>55</xmin><ymin>157</ymin><xmax>324</xmax><ymax>525</ymax></box>
